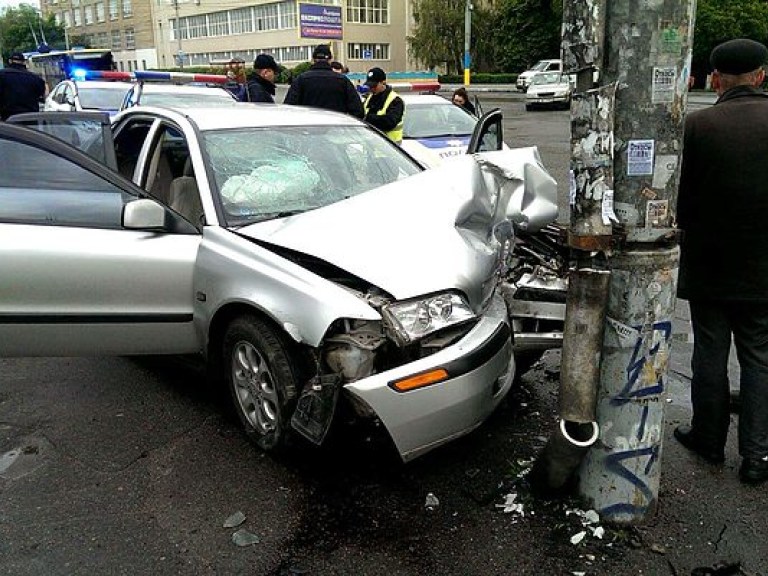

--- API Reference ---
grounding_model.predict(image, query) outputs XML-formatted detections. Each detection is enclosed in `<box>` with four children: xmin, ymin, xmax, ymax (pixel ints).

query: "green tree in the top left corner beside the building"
<box><xmin>0</xmin><ymin>4</ymin><xmax>65</xmax><ymax>58</ymax></box>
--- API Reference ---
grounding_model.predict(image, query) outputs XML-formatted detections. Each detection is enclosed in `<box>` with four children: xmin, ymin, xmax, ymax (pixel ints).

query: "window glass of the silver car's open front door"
<box><xmin>0</xmin><ymin>139</ymin><xmax>132</xmax><ymax>229</ymax></box>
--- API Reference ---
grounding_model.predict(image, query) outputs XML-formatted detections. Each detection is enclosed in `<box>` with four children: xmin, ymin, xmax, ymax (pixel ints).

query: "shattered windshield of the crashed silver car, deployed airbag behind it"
<box><xmin>202</xmin><ymin>126</ymin><xmax>421</xmax><ymax>226</ymax></box>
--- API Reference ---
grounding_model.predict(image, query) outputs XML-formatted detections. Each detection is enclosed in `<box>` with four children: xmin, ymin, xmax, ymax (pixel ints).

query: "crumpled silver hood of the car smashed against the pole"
<box><xmin>238</xmin><ymin>147</ymin><xmax>557</xmax><ymax>310</ymax></box>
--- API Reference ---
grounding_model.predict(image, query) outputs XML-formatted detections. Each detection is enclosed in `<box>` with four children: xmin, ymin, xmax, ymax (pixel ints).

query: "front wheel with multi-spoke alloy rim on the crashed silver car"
<box><xmin>222</xmin><ymin>315</ymin><xmax>298</xmax><ymax>452</ymax></box>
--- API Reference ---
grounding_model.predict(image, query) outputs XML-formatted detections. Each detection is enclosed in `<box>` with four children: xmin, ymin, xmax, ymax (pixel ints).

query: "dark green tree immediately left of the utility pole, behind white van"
<box><xmin>494</xmin><ymin>0</ymin><xmax>563</xmax><ymax>72</ymax></box>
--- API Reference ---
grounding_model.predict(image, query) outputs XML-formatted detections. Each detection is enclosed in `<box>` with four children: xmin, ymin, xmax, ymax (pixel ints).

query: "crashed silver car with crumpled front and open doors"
<box><xmin>0</xmin><ymin>104</ymin><xmax>557</xmax><ymax>460</ymax></box>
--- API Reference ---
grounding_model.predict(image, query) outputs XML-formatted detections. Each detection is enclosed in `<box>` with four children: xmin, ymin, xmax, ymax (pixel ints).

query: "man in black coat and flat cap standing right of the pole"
<box><xmin>675</xmin><ymin>39</ymin><xmax>768</xmax><ymax>483</ymax></box>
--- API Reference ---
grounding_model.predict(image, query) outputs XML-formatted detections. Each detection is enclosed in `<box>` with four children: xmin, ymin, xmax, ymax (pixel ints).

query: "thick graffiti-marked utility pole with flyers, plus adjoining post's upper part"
<box><xmin>561</xmin><ymin>0</ymin><xmax>696</xmax><ymax>524</ymax></box>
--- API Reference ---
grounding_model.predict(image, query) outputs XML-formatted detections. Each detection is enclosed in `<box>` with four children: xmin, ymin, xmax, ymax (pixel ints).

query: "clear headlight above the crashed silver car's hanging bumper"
<box><xmin>381</xmin><ymin>292</ymin><xmax>475</xmax><ymax>345</ymax></box>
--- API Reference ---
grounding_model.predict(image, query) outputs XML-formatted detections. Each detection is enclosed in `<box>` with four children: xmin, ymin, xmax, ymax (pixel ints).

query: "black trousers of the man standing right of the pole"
<box><xmin>689</xmin><ymin>300</ymin><xmax>768</xmax><ymax>458</ymax></box>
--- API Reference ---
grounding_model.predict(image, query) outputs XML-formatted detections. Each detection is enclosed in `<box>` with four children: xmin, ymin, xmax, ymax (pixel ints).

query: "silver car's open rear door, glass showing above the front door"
<box><xmin>8</xmin><ymin>112</ymin><xmax>117</xmax><ymax>170</ymax></box>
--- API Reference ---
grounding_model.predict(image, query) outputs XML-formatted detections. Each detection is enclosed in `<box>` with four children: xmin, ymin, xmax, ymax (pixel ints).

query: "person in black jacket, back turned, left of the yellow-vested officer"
<box><xmin>284</xmin><ymin>44</ymin><xmax>364</xmax><ymax>119</ymax></box>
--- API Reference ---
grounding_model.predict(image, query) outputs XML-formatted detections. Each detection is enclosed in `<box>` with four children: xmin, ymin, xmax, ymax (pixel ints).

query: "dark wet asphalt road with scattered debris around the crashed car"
<box><xmin>0</xmin><ymin>94</ymin><xmax>768</xmax><ymax>576</ymax></box>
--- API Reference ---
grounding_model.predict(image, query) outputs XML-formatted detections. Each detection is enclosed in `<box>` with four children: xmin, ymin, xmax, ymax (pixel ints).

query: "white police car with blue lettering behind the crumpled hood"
<box><xmin>400</xmin><ymin>93</ymin><xmax>506</xmax><ymax>168</ymax></box>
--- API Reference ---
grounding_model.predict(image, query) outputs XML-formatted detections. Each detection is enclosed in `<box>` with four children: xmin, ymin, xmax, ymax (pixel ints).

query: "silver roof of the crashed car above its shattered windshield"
<box><xmin>118</xmin><ymin>101</ymin><xmax>365</xmax><ymax>131</ymax></box>
